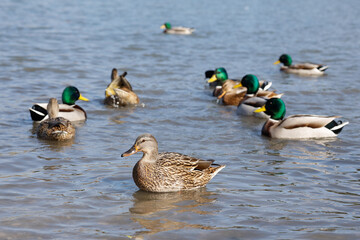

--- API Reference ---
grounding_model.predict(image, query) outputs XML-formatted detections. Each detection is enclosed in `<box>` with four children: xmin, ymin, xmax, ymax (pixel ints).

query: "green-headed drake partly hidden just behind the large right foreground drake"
<box><xmin>233</xmin><ymin>74</ymin><xmax>283</xmax><ymax>118</ymax></box>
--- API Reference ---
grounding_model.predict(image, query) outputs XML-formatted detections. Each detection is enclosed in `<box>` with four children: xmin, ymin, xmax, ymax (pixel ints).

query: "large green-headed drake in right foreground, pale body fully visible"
<box><xmin>255</xmin><ymin>98</ymin><xmax>349</xmax><ymax>139</ymax></box>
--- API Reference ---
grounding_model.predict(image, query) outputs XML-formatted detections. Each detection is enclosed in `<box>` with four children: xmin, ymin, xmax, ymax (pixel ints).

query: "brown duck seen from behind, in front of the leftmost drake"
<box><xmin>36</xmin><ymin>98</ymin><xmax>75</xmax><ymax>141</ymax></box>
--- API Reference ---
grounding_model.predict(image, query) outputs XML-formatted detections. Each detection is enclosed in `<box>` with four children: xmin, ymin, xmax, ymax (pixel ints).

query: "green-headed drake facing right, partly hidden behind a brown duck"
<box><xmin>29</xmin><ymin>86</ymin><xmax>89</xmax><ymax>122</ymax></box>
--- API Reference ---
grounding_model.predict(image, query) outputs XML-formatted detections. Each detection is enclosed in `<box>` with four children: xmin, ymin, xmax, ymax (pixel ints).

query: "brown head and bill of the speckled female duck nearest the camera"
<box><xmin>121</xmin><ymin>133</ymin><xmax>158</xmax><ymax>157</ymax></box>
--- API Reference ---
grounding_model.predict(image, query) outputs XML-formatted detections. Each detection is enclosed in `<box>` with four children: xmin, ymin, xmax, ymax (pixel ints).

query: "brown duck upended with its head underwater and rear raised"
<box><xmin>105</xmin><ymin>68</ymin><xmax>139</xmax><ymax>106</ymax></box>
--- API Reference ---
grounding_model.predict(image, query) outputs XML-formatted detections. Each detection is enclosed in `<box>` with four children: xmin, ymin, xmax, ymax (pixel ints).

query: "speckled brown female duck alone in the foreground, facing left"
<box><xmin>121</xmin><ymin>134</ymin><xmax>225</xmax><ymax>192</ymax></box>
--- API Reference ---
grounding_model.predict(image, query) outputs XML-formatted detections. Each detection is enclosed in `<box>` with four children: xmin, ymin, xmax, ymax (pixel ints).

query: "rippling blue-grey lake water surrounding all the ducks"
<box><xmin>0</xmin><ymin>0</ymin><xmax>360</xmax><ymax>240</ymax></box>
